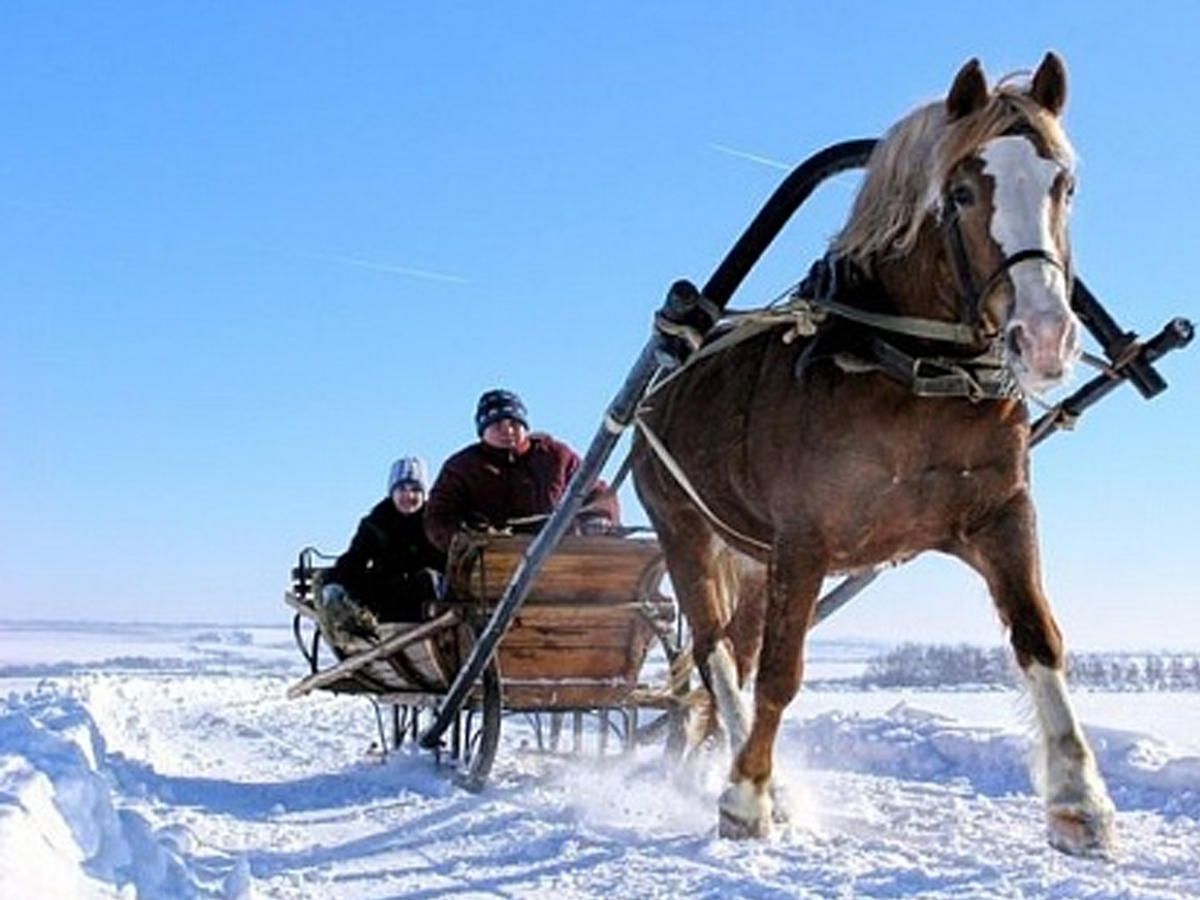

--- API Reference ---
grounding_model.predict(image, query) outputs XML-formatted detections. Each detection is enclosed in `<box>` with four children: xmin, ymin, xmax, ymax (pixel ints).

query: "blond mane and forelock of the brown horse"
<box><xmin>832</xmin><ymin>78</ymin><xmax>1075</xmax><ymax>272</ymax></box>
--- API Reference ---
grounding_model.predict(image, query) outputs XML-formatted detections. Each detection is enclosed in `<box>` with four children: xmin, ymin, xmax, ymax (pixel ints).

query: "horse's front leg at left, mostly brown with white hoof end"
<box><xmin>718</xmin><ymin>529</ymin><xmax>824</xmax><ymax>838</ymax></box>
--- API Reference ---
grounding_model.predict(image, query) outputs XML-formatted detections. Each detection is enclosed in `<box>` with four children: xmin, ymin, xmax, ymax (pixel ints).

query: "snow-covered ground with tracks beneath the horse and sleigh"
<box><xmin>0</xmin><ymin>622</ymin><xmax>1200</xmax><ymax>900</ymax></box>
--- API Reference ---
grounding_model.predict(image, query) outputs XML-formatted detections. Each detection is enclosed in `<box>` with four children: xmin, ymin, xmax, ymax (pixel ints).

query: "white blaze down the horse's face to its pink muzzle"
<box><xmin>979</xmin><ymin>134</ymin><xmax>1079</xmax><ymax>394</ymax></box>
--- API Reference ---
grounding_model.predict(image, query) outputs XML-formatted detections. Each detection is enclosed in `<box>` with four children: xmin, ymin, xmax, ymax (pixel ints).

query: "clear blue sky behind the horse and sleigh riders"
<box><xmin>0</xmin><ymin>1</ymin><xmax>1200</xmax><ymax>647</ymax></box>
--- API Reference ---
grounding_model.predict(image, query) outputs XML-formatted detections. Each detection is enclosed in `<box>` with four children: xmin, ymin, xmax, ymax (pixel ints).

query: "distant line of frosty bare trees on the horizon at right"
<box><xmin>857</xmin><ymin>643</ymin><xmax>1200</xmax><ymax>691</ymax></box>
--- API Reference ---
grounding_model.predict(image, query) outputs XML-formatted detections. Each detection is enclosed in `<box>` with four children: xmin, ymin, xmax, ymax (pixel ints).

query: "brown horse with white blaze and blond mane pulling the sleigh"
<box><xmin>634</xmin><ymin>53</ymin><xmax>1112</xmax><ymax>854</ymax></box>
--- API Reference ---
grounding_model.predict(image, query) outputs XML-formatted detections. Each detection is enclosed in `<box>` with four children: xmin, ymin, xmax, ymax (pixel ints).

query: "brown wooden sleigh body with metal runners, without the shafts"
<box><xmin>286</xmin><ymin>533</ymin><xmax>690</xmax><ymax>790</ymax></box>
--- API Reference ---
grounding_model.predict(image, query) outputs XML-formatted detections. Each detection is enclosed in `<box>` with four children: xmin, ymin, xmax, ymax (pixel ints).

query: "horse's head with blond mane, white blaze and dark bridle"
<box><xmin>835</xmin><ymin>53</ymin><xmax>1080</xmax><ymax>394</ymax></box>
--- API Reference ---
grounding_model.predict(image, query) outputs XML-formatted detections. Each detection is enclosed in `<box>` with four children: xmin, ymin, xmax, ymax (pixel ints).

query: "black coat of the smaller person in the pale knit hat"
<box><xmin>324</xmin><ymin>497</ymin><xmax>445</xmax><ymax>622</ymax></box>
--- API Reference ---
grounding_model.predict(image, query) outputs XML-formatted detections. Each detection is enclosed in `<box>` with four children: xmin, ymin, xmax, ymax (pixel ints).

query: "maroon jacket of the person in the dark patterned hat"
<box><xmin>425</xmin><ymin>433</ymin><xmax>619</xmax><ymax>552</ymax></box>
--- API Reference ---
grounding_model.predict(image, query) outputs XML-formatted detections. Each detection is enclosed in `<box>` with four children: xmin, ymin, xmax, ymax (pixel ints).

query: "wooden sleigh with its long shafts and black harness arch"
<box><xmin>288</xmin><ymin>139</ymin><xmax>1193</xmax><ymax>790</ymax></box>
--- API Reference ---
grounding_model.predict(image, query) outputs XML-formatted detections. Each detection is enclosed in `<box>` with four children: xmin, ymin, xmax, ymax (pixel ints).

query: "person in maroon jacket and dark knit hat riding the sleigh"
<box><xmin>425</xmin><ymin>390</ymin><xmax>619</xmax><ymax>552</ymax></box>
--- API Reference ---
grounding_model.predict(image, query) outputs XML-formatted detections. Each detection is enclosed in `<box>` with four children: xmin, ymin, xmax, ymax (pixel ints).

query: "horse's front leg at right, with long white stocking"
<box><xmin>964</xmin><ymin>494</ymin><xmax>1114</xmax><ymax>856</ymax></box>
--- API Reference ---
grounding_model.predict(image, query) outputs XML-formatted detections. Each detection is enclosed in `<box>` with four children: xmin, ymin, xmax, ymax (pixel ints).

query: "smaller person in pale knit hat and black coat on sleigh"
<box><xmin>320</xmin><ymin>456</ymin><xmax>445</xmax><ymax>636</ymax></box>
